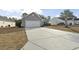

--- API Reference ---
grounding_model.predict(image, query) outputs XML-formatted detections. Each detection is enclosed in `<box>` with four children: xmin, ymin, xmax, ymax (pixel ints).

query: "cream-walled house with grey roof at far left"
<box><xmin>0</xmin><ymin>17</ymin><xmax>15</xmax><ymax>27</ymax></box>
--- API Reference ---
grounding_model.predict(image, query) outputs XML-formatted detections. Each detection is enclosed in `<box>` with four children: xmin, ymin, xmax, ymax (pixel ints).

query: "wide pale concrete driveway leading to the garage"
<box><xmin>22</xmin><ymin>28</ymin><xmax>79</xmax><ymax>50</ymax></box>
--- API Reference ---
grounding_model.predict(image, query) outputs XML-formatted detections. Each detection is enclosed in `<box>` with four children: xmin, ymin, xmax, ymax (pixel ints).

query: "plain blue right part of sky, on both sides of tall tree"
<box><xmin>43</xmin><ymin>9</ymin><xmax>79</xmax><ymax>17</ymax></box>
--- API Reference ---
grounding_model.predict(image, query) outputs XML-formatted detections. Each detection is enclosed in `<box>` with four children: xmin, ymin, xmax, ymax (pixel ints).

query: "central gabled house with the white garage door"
<box><xmin>21</xmin><ymin>12</ymin><xmax>44</xmax><ymax>28</ymax></box>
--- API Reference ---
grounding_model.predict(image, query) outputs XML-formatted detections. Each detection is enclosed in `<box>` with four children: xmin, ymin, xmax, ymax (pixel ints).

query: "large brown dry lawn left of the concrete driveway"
<box><xmin>0</xmin><ymin>28</ymin><xmax>28</xmax><ymax>50</ymax></box>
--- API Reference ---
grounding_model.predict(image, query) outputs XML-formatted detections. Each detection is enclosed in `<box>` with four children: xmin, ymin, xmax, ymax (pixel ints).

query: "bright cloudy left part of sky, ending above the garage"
<box><xmin>0</xmin><ymin>9</ymin><xmax>42</xmax><ymax>19</ymax></box>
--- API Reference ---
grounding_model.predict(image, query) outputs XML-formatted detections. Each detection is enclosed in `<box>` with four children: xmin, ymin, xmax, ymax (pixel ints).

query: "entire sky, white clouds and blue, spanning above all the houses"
<box><xmin>0</xmin><ymin>9</ymin><xmax>79</xmax><ymax>18</ymax></box>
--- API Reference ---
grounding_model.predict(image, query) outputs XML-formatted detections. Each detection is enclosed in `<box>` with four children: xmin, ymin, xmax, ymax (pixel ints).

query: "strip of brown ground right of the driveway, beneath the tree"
<box><xmin>47</xmin><ymin>25</ymin><xmax>79</xmax><ymax>33</ymax></box>
